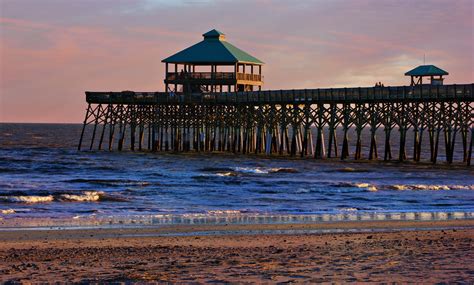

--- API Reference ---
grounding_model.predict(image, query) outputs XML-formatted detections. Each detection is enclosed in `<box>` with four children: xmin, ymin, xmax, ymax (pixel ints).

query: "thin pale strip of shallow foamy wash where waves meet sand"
<box><xmin>0</xmin><ymin>210</ymin><xmax>474</xmax><ymax>227</ymax></box>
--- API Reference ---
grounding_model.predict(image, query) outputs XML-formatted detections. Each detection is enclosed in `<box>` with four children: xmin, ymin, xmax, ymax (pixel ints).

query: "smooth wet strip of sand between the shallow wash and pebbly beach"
<box><xmin>0</xmin><ymin>219</ymin><xmax>474</xmax><ymax>235</ymax></box>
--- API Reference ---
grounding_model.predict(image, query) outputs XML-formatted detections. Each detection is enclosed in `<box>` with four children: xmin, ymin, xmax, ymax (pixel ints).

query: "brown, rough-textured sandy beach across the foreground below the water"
<box><xmin>0</xmin><ymin>220</ymin><xmax>474</xmax><ymax>283</ymax></box>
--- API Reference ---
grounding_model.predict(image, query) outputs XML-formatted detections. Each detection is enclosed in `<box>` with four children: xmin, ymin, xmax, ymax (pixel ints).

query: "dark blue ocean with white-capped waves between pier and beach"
<box><xmin>0</xmin><ymin>123</ymin><xmax>474</xmax><ymax>227</ymax></box>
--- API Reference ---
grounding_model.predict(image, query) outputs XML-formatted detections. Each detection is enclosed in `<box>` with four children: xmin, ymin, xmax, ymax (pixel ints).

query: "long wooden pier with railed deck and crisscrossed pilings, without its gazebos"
<box><xmin>78</xmin><ymin>84</ymin><xmax>474</xmax><ymax>165</ymax></box>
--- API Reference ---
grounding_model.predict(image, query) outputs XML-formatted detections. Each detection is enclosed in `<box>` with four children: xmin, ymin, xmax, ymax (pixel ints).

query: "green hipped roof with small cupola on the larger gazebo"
<box><xmin>162</xmin><ymin>29</ymin><xmax>263</xmax><ymax>65</ymax></box>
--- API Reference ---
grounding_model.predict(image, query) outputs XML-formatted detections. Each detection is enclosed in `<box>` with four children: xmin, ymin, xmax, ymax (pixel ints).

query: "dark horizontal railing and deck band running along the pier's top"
<box><xmin>86</xmin><ymin>84</ymin><xmax>474</xmax><ymax>105</ymax></box>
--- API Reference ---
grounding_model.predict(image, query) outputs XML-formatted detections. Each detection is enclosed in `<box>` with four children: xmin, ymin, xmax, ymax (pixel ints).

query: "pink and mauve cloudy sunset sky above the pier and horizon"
<box><xmin>0</xmin><ymin>0</ymin><xmax>474</xmax><ymax>123</ymax></box>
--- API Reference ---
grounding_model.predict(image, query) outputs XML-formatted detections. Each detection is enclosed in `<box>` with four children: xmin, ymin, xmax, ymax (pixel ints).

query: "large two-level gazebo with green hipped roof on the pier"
<box><xmin>162</xmin><ymin>30</ymin><xmax>263</xmax><ymax>93</ymax></box>
